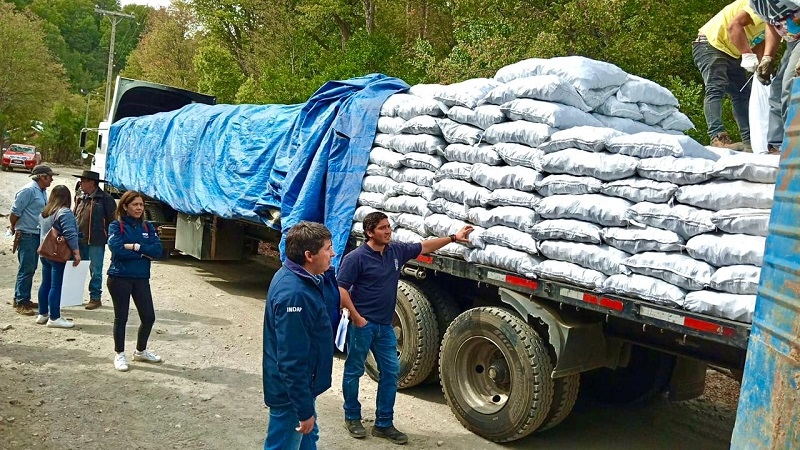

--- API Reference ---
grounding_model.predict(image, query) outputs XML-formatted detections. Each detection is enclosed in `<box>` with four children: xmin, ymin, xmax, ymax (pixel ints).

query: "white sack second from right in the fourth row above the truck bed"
<box><xmin>627</xmin><ymin>202</ymin><xmax>716</xmax><ymax>239</ymax></box>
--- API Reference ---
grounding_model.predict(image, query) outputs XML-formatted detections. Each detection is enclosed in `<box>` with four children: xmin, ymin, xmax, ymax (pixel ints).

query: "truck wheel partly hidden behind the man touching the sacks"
<box><xmin>366</xmin><ymin>280</ymin><xmax>439</xmax><ymax>389</ymax></box>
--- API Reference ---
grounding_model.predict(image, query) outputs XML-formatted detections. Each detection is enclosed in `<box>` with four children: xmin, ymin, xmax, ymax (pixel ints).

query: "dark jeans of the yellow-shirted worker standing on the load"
<box><xmin>692</xmin><ymin>42</ymin><xmax>750</xmax><ymax>142</ymax></box>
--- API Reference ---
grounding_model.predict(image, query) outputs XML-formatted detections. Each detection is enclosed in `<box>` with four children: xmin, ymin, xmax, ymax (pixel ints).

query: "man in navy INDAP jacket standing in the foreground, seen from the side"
<box><xmin>263</xmin><ymin>222</ymin><xmax>339</xmax><ymax>450</ymax></box>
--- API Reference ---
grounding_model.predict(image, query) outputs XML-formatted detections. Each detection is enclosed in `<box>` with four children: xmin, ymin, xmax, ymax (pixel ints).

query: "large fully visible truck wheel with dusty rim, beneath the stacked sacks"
<box><xmin>439</xmin><ymin>307</ymin><xmax>554</xmax><ymax>442</ymax></box>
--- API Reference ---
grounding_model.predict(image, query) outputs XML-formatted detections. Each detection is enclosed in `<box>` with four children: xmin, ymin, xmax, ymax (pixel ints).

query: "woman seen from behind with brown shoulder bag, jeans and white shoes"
<box><xmin>36</xmin><ymin>184</ymin><xmax>81</xmax><ymax>328</ymax></box>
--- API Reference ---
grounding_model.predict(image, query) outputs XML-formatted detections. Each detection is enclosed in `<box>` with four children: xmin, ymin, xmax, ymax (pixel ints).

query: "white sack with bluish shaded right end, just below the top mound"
<box><xmin>500</xmin><ymin>98</ymin><xmax>602</xmax><ymax>130</ymax></box>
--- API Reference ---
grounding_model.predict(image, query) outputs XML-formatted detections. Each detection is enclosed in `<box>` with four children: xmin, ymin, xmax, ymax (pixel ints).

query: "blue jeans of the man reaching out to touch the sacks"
<box><xmin>342</xmin><ymin>322</ymin><xmax>400</xmax><ymax>428</ymax></box>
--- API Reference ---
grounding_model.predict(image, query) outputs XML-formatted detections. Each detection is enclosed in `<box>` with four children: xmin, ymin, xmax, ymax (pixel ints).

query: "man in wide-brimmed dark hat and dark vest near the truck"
<box><xmin>75</xmin><ymin>170</ymin><xmax>117</xmax><ymax>309</ymax></box>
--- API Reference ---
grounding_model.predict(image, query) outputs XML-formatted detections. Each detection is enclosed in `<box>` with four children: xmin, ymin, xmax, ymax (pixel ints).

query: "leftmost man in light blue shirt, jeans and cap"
<box><xmin>9</xmin><ymin>165</ymin><xmax>58</xmax><ymax>316</ymax></box>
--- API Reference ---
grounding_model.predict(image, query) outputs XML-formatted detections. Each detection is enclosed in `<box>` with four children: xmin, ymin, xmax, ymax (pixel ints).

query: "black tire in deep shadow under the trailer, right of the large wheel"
<box><xmin>581</xmin><ymin>345</ymin><xmax>675</xmax><ymax>404</ymax></box>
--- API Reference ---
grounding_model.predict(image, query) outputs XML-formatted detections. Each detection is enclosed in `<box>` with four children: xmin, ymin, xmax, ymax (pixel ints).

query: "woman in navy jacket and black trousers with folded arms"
<box><xmin>106</xmin><ymin>191</ymin><xmax>162</xmax><ymax>372</ymax></box>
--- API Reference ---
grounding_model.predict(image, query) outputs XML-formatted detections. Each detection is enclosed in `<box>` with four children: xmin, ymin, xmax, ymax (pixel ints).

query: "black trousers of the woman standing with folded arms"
<box><xmin>106</xmin><ymin>276</ymin><xmax>156</xmax><ymax>353</ymax></box>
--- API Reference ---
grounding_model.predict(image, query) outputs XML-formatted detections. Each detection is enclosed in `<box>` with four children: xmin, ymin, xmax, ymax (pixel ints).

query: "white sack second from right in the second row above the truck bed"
<box><xmin>624</xmin><ymin>252</ymin><xmax>714</xmax><ymax>291</ymax></box>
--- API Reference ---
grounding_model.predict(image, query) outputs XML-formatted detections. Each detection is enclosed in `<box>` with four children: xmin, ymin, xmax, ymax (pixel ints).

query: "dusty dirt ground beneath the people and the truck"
<box><xmin>0</xmin><ymin>168</ymin><xmax>738</xmax><ymax>450</ymax></box>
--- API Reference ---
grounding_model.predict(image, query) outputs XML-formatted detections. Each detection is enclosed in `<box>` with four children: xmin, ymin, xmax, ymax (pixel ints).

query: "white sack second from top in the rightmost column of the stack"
<box><xmin>675</xmin><ymin>180</ymin><xmax>775</xmax><ymax>211</ymax></box>
